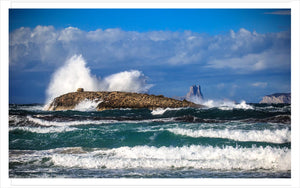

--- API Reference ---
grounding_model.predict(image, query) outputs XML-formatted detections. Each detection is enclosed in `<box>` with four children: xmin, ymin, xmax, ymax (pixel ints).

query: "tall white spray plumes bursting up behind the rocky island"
<box><xmin>44</xmin><ymin>55</ymin><xmax>153</xmax><ymax>104</ymax></box>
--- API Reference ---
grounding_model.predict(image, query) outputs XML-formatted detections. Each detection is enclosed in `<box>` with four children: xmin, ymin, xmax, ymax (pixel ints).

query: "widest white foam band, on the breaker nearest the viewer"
<box><xmin>51</xmin><ymin>145</ymin><xmax>291</xmax><ymax>171</ymax></box>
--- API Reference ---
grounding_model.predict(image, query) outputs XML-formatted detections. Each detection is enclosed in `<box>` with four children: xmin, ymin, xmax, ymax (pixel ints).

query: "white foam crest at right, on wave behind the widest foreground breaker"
<box><xmin>167</xmin><ymin>128</ymin><xmax>291</xmax><ymax>143</ymax></box>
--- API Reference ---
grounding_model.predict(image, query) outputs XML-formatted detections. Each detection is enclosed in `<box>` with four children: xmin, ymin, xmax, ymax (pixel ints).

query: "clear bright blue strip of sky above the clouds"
<box><xmin>9</xmin><ymin>9</ymin><xmax>291</xmax><ymax>34</ymax></box>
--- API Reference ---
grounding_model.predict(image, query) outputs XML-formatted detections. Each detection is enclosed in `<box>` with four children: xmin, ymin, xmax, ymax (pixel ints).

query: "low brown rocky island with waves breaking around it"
<box><xmin>48</xmin><ymin>88</ymin><xmax>203</xmax><ymax>111</ymax></box>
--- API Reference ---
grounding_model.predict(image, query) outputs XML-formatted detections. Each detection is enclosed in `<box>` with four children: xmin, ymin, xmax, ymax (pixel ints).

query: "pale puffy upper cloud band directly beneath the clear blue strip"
<box><xmin>9</xmin><ymin>26</ymin><xmax>291</xmax><ymax>74</ymax></box>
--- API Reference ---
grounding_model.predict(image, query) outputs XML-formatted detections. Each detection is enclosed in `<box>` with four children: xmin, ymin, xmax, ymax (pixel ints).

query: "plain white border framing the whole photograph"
<box><xmin>0</xmin><ymin>0</ymin><xmax>300</xmax><ymax>187</ymax></box>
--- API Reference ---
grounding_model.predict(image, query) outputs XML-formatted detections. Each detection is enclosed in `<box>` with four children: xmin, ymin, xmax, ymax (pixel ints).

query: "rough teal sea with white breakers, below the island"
<box><xmin>9</xmin><ymin>102</ymin><xmax>291</xmax><ymax>178</ymax></box>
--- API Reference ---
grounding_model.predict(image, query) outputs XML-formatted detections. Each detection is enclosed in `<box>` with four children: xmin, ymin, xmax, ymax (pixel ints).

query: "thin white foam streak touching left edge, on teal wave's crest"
<box><xmin>9</xmin><ymin>126</ymin><xmax>77</xmax><ymax>134</ymax></box>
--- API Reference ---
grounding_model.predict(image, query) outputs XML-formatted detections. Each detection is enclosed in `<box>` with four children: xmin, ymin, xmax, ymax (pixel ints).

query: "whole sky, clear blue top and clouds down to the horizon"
<box><xmin>9</xmin><ymin>9</ymin><xmax>291</xmax><ymax>104</ymax></box>
